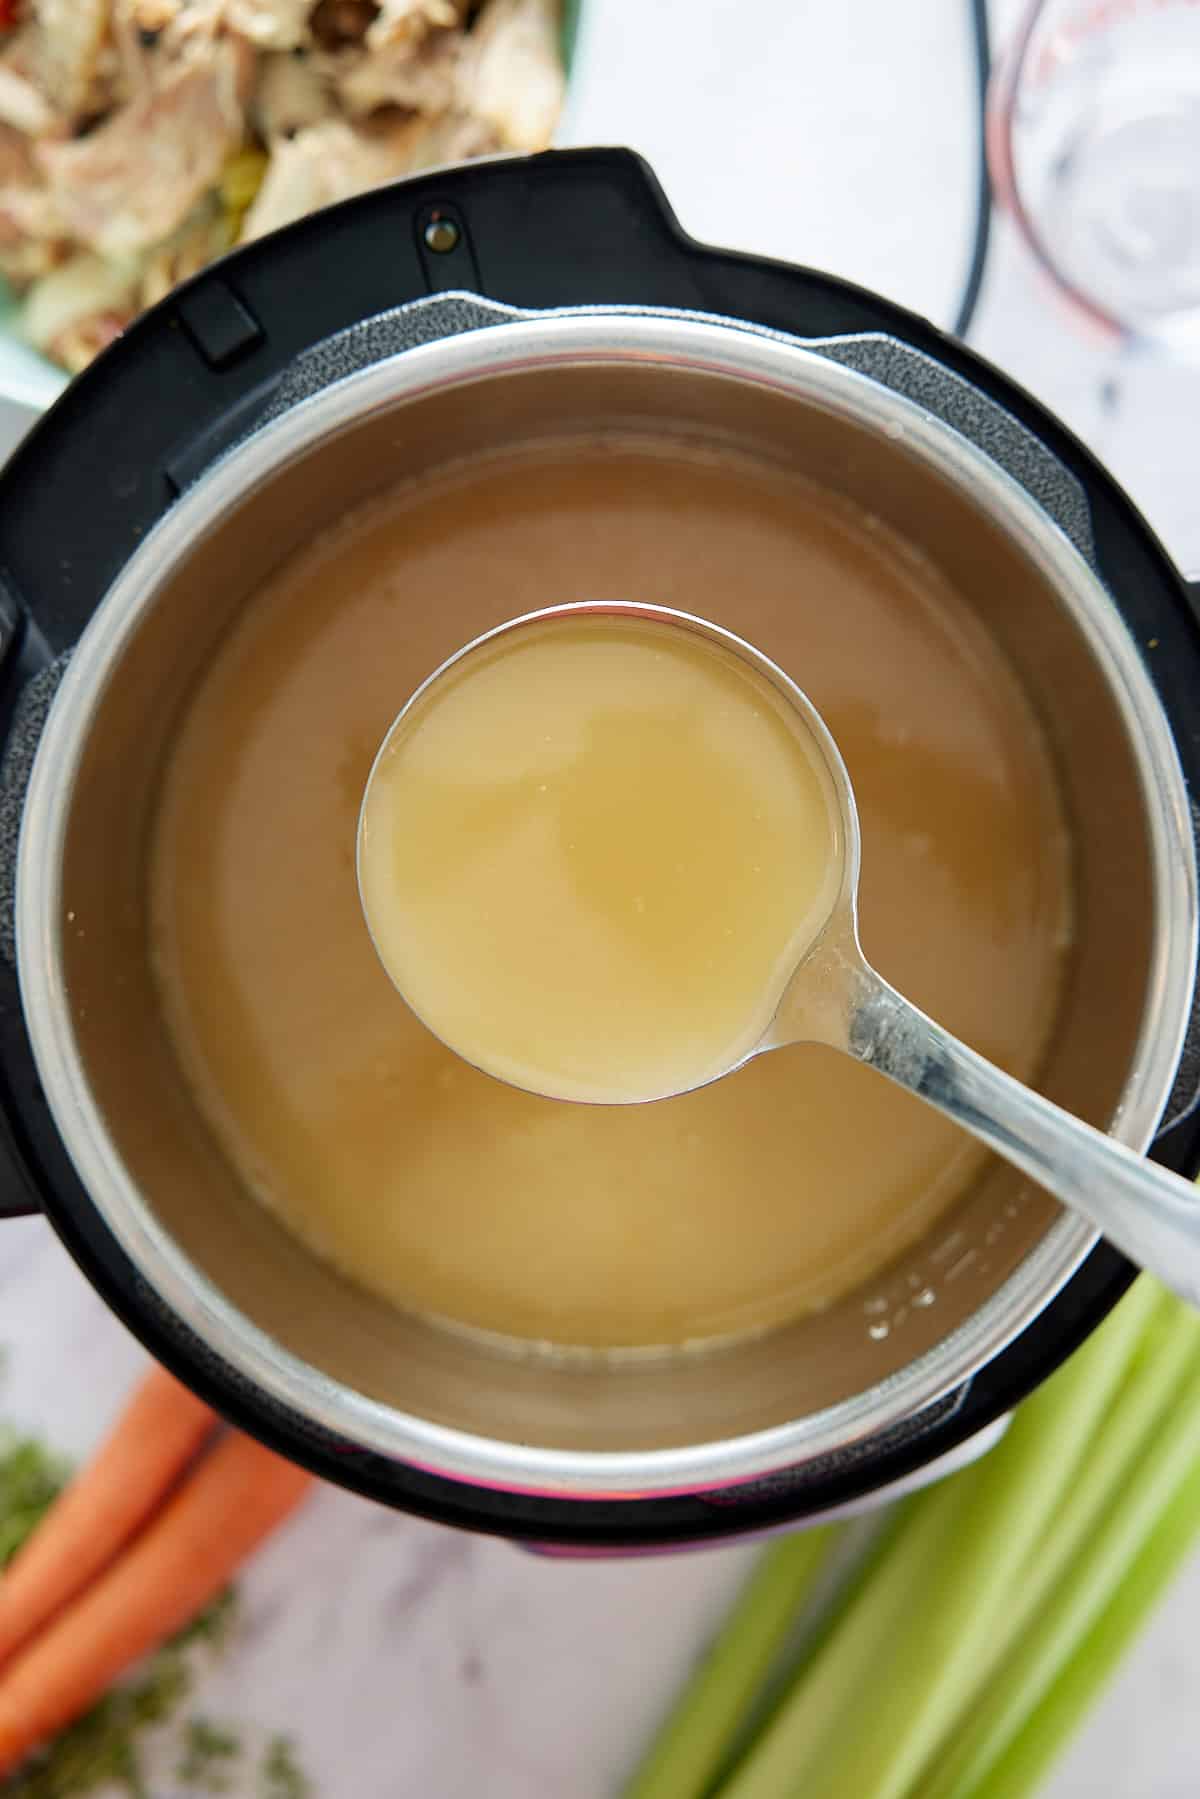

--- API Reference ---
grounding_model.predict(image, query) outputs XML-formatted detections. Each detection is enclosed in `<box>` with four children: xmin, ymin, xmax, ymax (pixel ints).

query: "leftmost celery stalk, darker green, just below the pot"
<box><xmin>624</xmin><ymin>1524</ymin><xmax>842</xmax><ymax>1799</ymax></box>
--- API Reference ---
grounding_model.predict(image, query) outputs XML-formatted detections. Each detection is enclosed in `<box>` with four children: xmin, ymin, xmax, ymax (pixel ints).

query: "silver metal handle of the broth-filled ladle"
<box><xmin>846</xmin><ymin>968</ymin><xmax>1200</xmax><ymax>1308</ymax></box>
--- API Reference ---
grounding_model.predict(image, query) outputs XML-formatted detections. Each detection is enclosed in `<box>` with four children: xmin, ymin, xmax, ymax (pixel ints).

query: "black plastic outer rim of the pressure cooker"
<box><xmin>0</xmin><ymin>151</ymin><xmax>1200</xmax><ymax>1549</ymax></box>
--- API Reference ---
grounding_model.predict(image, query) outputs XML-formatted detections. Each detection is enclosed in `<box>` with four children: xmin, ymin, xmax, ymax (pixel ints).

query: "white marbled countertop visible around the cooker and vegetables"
<box><xmin>0</xmin><ymin>0</ymin><xmax>1200</xmax><ymax>1799</ymax></box>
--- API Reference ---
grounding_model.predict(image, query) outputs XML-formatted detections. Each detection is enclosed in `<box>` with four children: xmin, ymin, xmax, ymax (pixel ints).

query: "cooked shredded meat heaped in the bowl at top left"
<box><xmin>0</xmin><ymin>0</ymin><xmax>563</xmax><ymax>372</ymax></box>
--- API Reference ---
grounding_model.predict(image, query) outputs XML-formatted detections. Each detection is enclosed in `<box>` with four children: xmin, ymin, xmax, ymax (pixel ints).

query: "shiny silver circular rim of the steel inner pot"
<box><xmin>16</xmin><ymin>311</ymin><xmax>1196</xmax><ymax>1497</ymax></box>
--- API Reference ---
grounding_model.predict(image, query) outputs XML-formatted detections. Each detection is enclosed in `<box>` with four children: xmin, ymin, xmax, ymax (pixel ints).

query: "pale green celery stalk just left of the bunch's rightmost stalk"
<box><xmin>921</xmin><ymin>1299</ymin><xmax>1200</xmax><ymax>1799</ymax></box>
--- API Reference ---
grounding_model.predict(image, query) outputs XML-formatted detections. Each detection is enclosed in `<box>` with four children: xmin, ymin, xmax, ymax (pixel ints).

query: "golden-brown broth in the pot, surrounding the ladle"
<box><xmin>149</xmin><ymin>439</ymin><xmax>1069</xmax><ymax>1347</ymax></box>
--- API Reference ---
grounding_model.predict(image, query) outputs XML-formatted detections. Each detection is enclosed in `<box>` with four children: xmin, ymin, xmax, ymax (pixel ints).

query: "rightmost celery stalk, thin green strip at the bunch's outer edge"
<box><xmin>972</xmin><ymin>1459</ymin><xmax>1200</xmax><ymax>1799</ymax></box>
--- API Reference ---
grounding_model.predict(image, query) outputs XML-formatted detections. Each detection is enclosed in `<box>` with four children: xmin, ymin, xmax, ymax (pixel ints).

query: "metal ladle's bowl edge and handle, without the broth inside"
<box><xmin>360</xmin><ymin>601</ymin><xmax>1200</xmax><ymax>1306</ymax></box>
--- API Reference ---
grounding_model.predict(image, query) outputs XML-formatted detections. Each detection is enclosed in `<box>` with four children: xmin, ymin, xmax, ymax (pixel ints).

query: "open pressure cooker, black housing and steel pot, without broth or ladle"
<box><xmin>0</xmin><ymin>149</ymin><xmax>1200</xmax><ymax>1553</ymax></box>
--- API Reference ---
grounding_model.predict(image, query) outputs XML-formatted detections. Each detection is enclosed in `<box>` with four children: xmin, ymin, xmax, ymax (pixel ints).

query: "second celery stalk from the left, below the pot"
<box><xmin>718</xmin><ymin>1470</ymin><xmax>973</xmax><ymax>1799</ymax></box>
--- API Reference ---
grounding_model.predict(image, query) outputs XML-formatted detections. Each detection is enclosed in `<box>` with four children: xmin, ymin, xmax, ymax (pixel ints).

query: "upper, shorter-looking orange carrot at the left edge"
<box><xmin>0</xmin><ymin>1367</ymin><xmax>216</xmax><ymax>1668</ymax></box>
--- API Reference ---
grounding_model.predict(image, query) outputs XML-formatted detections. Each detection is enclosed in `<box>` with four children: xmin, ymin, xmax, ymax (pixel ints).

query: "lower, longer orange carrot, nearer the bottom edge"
<box><xmin>0</xmin><ymin>1432</ymin><xmax>313</xmax><ymax>1777</ymax></box>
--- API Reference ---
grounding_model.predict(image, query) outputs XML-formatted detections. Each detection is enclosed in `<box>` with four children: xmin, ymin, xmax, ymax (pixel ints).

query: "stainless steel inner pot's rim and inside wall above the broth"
<box><xmin>18</xmin><ymin>313</ymin><xmax>1196</xmax><ymax>1497</ymax></box>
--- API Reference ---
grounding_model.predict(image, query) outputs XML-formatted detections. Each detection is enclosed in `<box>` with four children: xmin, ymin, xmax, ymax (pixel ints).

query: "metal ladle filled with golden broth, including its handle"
<box><xmin>358</xmin><ymin>603</ymin><xmax>1200</xmax><ymax>1304</ymax></box>
